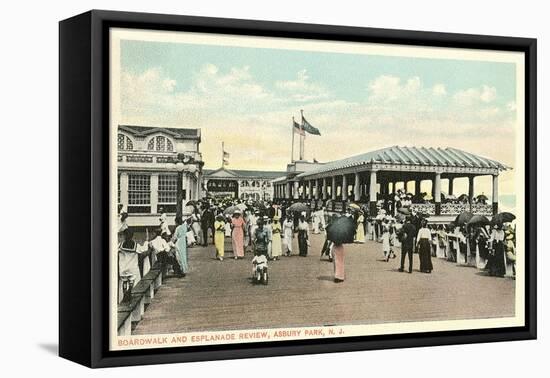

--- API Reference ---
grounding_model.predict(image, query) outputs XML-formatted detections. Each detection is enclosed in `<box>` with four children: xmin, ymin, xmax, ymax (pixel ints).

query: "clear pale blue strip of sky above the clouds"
<box><xmin>121</xmin><ymin>40</ymin><xmax>516</xmax><ymax>110</ymax></box>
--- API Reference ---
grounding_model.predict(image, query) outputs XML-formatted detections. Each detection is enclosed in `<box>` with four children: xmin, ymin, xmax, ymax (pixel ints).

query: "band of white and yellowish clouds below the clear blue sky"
<box><xmin>121</xmin><ymin>68</ymin><xmax>515</xmax><ymax>189</ymax></box>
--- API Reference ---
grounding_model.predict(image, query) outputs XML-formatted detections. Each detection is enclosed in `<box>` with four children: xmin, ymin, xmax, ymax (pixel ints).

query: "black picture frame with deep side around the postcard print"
<box><xmin>59</xmin><ymin>10</ymin><xmax>537</xmax><ymax>367</ymax></box>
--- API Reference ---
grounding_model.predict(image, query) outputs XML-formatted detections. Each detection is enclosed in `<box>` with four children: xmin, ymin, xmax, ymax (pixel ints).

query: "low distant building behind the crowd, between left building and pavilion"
<box><xmin>203</xmin><ymin>168</ymin><xmax>286</xmax><ymax>201</ymax></box>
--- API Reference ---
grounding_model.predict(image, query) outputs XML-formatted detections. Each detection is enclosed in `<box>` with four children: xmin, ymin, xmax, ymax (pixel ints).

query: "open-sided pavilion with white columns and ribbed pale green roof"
<box><xmin>273</xmin><ymin>146</ymin><xmax>511</xmax><ymax>216</ymax></box>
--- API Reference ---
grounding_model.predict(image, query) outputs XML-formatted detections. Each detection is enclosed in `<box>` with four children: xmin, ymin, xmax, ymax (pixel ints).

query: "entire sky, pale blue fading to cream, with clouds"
<box><xmin>120</xmin><ymin>40</ymin><xmax>517</xmax><ymax>193</ymax></box>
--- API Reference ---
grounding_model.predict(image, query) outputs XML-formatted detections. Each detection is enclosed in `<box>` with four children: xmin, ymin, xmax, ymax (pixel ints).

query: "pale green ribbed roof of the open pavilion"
<box><xmin>297</xmin><ymin>146</ymin><xmax>511</xmax><ymax>178</ymax></box>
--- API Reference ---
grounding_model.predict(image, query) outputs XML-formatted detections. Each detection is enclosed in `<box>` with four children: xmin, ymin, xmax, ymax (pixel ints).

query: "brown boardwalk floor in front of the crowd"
<box><xmin>134</xmin><ymin>235</ymin><xmax>515</xmax><ymax>334</ymax></box>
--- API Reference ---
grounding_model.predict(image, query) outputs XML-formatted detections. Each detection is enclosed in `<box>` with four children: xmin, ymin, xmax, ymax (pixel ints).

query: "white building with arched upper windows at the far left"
<box><xmin>117</xmin><ymin>125</ymin><xmax>203</xmax><ymax>226</ymax></box>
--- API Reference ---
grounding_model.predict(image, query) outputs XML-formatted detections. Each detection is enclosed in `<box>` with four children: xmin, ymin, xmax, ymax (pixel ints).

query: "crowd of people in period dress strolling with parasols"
<box><xmin>119</xmin><ymin>195</ymin><xmax>515</xmax><ymax>298</ymax></box>
